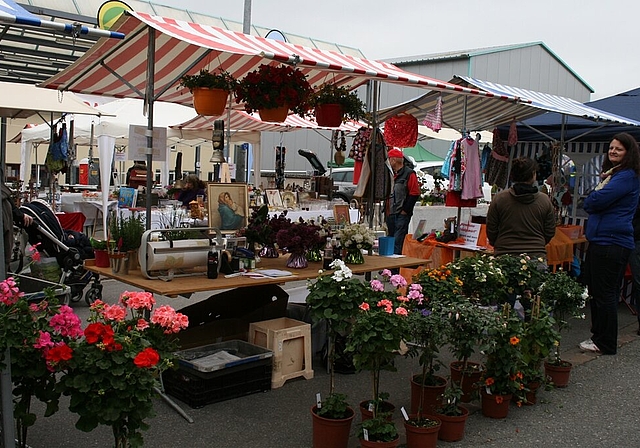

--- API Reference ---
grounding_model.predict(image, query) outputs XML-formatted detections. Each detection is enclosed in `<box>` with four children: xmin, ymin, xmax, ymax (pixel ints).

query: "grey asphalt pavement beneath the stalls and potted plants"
<box><xmin>17</xmin><ymin>280</ymin><xmax>640</xmax><ymax>448</ymax></box>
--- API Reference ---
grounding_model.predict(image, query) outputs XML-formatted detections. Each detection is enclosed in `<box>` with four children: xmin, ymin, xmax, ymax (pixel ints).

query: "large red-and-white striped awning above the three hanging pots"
<box><xmin>37</xmin><ymin>11</ymin><xmax>516</xmax><ymax>106</ymax></box>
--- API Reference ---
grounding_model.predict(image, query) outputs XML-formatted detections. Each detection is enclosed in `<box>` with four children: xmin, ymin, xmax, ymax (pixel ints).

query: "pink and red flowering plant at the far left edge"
<box><xmin>0</xmin><ymin>276</ymin><xmax>82</xmax><ymax>447</ymax></box>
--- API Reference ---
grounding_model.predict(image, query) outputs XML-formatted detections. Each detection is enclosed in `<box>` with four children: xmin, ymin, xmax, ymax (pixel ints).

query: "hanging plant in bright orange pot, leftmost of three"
<box><xmin>180</xmin><ymin>68</ymin><xmax>237</xmax><ymax>116</ymax></box>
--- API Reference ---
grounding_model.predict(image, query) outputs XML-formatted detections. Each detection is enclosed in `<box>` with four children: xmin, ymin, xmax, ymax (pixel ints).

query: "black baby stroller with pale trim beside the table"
<box><xmin>20</xmin><ymin>199</ymin><xmax>100</xmax><ymax>304</ymax></box>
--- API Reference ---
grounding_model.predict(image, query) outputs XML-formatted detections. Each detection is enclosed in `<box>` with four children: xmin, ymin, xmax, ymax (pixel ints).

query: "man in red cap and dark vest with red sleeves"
<box><xmin>387</xmin><ymin>148</ymin><xmax>420</xmax><ymax>255</ymax></box>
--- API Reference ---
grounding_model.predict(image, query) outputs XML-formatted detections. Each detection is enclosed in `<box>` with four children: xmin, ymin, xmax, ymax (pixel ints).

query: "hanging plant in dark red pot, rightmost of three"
<box><xmin>309</xmin><ymin>82</ymin><xmax>365</xmax><ymax>127</ymax></box>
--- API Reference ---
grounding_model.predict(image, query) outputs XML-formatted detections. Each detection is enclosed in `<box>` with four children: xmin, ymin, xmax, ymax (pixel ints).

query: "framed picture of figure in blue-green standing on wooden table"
<box><xmin>207</xmin><ymin>182</ymin><xmax>249</xmax><ymax>233</ymax></box>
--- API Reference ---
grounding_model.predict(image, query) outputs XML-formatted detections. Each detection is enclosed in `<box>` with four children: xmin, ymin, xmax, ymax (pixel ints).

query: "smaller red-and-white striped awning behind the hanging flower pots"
<box><xmin>169</xmin><ymin>110</ymin><xmax>366</xmax><ymax>133</ymax></box>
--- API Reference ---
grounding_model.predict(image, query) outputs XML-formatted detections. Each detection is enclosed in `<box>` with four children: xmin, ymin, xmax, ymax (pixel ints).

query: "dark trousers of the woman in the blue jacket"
<box><xmin>582</xmin><ymin>243</ymin><xmax>631</xmax><ymax>355</ymax></box>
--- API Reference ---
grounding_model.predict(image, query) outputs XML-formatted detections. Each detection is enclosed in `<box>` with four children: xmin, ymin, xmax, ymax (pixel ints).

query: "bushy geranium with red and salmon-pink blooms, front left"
<box><xmin>56</xmin><ymin>291</ymin><xmax>189</xmax><ymax>448</ymax></box>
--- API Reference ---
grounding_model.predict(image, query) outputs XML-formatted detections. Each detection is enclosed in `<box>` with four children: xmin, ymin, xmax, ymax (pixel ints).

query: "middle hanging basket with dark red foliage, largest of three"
<box><xmin>235</xmin><ymin>64</ymin><xmax>312</xmax><ymax>122</ymax></box>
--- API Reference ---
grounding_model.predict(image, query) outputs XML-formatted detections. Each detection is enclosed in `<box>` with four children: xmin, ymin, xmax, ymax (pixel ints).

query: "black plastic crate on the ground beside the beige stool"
<box><xmin>162</xmin><ymin>341</ymin><xmax>273</xmax><ymax>408</ymax></box>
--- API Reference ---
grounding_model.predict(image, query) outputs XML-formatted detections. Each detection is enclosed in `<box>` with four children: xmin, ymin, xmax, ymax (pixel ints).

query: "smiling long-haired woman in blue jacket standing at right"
<box><xmin>580</xmin><ymin>133</ymin><xmax>640</xmax><ymax>355</ymax></box>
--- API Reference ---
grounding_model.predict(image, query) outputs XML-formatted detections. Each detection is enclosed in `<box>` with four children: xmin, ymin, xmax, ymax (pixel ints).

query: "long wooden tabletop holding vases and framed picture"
<box><xmin>84</xmin><ymin>255</ymin><xmax>428</xmax><ymax>297</ymax></box>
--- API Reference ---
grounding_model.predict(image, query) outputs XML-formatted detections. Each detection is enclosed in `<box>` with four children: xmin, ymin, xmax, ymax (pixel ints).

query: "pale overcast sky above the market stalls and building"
<box><xmin>154</xmin><ymin>0</ymin><xmax>640</xmax><ymax>99</ymax></box>
